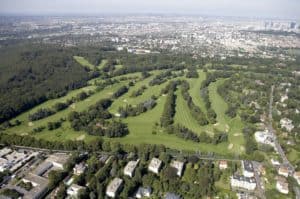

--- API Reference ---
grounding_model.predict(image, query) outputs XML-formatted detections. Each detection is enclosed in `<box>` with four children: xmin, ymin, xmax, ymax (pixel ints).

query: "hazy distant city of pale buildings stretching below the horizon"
<box><xmin>0</xmin><ymin>15</ymin><xmax>300</xmax><ymax>60</ymax></box>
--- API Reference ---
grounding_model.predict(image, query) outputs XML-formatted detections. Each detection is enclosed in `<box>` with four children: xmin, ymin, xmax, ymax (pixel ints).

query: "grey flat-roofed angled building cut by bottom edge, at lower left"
<box><xmin>22</xmin><ymin>173</ymin><xmax>48</xmax><ymax>199</ymax></box>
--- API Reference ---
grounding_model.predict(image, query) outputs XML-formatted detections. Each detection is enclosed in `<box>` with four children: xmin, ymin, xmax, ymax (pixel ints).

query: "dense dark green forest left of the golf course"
<box><xmin>0</xmin><ymin>44</ymin><xmax>97</xmax><ymax>122</ymax></box>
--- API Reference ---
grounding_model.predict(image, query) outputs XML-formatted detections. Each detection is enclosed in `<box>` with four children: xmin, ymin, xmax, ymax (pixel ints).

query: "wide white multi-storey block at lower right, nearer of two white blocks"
<box><xmin>230</xmin><ymin>175</ymin><xmax>256</xmax><ymax>191</ymax></box>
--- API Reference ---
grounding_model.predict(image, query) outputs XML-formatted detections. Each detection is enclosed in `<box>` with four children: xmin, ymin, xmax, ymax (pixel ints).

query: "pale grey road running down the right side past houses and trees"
<box><xmin>268</xmin><ymin>85</ymin><xmax>300</xmax><ymax>199</ymax></box>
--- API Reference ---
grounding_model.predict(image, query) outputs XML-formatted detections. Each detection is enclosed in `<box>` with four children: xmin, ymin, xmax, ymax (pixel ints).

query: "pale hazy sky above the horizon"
<box><xmin>0</xmin><ymin>0</ymin><xmax>300</xmax><ymax>20</ymax></box>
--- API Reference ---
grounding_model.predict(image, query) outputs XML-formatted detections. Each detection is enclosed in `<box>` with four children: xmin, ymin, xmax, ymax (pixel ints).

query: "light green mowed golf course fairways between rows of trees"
<box><xmin>6</xmin><ymin>57</ymin><xmax>244</xmax><ymax>155</ymax></box>
